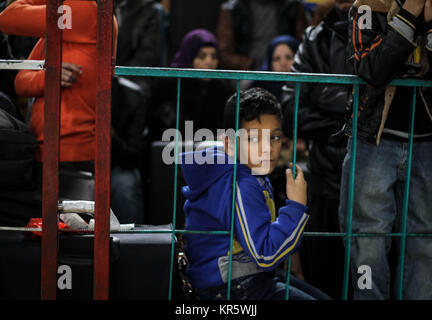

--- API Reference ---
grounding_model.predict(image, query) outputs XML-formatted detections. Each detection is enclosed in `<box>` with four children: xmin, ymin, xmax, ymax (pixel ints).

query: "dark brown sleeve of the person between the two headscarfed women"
<box><xmin>216</xmin><ymin>7</ymin><xmax>254</xmax><ymax>70</ymax></box>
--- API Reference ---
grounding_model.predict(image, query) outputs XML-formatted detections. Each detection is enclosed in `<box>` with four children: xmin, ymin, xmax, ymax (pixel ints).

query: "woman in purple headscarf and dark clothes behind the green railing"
<box><xmin>151</xmin><ymin>29</ymin><xmax>234</xmax><ymax>140</ymax></box>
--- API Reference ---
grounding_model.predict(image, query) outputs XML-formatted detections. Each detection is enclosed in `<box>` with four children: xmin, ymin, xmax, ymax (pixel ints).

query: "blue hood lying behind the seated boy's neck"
<box><xmin>180</xmin><ymin>148</ymin><xmax>249</xmax><ymax>200</ymax></box>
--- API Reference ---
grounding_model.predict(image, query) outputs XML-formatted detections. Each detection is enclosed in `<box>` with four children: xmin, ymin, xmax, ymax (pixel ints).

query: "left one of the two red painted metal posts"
<box><xmin>41</xmin><ymin>0</ymin><xmax>62</xmax><ymax>300</ymax></box>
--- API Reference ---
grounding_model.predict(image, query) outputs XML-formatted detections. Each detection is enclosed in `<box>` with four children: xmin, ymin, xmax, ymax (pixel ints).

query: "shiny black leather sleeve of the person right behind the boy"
<box><xmin>281</xmin><ymin>25</ymin><xmax>348</xmax><ymax>140</ymax></box>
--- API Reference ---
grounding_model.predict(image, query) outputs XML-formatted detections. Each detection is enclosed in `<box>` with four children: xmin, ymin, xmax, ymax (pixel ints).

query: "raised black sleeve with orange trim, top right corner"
<box><xmin>349</xmin><ymin>7</ymin><xmax>417</xmax><ymax>86</ymax></box>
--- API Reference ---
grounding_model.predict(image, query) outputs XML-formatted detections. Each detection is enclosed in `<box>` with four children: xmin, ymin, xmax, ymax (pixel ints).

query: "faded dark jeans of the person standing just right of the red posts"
<box><xmin>111</xmin><ymin>166</ymin><xmax>144</xmax><ymax>224</ymax></box>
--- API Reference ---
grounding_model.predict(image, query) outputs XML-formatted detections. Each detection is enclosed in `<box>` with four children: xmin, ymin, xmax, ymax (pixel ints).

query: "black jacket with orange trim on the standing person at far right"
<box><xmin>345</xmin><ymin>1</ymin><xmax>432</xmax><ymax>144</ymax></box>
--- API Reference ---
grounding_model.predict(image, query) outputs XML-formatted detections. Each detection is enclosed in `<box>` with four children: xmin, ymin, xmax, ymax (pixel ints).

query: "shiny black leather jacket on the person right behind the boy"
<box><xmin>282</xmin><ymin>8</ymin><xmax>352</xmax><ymax>199</ymax></box>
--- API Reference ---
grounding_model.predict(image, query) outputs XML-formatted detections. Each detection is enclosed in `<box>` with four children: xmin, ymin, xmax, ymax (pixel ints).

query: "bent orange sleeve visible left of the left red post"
<box><xmin>15</xmin><ymin>39</ymin><xmax>45</xmax><ymax>97</ymax></box>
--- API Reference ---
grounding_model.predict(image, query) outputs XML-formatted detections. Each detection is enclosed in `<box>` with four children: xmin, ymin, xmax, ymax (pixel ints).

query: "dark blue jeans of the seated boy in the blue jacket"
<box><xmin>198</xmin><ymin>272</ymin><xmax>328</xmax><ymax>300</ymax></box>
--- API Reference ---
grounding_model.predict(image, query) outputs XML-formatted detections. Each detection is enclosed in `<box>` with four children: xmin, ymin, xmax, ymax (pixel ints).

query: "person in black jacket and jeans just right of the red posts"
<box><xmin>111</xmin><ymin>0</ymin><xmax>163</xmax><ymax>223</ymax></box>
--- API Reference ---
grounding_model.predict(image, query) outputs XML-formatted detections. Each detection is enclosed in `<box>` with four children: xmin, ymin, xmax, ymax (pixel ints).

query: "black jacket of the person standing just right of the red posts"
<box><xmin>112</xmin><ymin>0</ymin><xmax>163</xmax><ymax>168</ymax></box>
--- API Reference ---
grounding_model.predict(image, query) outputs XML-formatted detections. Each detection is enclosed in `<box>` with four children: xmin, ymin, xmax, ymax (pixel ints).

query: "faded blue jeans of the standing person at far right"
<box><xmin>339</xmin><ymin>139</ymin><xmax>432</xmax><ymax>299</ymax></box>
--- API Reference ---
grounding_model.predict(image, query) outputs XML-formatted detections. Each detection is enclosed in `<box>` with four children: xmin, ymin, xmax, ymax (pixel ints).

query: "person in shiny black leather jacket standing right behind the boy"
<box><xmin>282</xmin><ymin>0</ymin><xmax>353</xmax><ymax>298</ymax></box>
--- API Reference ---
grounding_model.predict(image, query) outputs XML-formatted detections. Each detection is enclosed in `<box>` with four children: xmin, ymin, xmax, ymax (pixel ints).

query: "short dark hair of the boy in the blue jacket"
<box><xmin>224</xmin><ymin>88</ymin><xmax>282</xmax><ymax>131</ymax></box>
